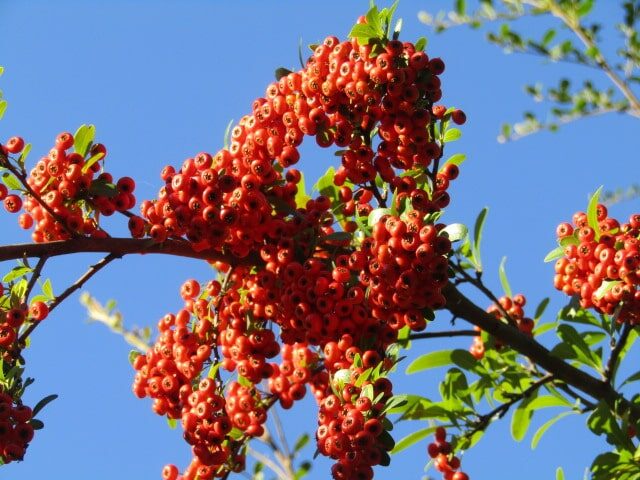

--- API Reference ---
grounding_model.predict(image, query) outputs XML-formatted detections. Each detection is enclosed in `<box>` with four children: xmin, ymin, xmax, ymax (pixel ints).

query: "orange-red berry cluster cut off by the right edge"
<box><xmin>554</xmin><ymin>205</ymin><xmax>640</xmax><ymax>325</ymax></box>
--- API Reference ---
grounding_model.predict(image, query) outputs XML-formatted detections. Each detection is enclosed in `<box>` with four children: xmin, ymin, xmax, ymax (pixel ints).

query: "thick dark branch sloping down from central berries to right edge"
<box><xmin>443</xmin><ymin>284</ymin><xmax>640</xmax><ymax>419</ymax></box>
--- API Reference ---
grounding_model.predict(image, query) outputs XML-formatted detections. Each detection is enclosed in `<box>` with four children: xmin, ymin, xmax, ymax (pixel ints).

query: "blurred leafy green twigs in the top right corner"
<box><xmin>419</xmin><ymin>0</ymin><xmax>640</xmax><ymax>142</ymax></box>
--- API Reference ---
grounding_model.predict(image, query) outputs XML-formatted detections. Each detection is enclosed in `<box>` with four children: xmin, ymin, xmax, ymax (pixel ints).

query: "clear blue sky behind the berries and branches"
<box><xmin>0</xmin><ymin>0</ymin><xmax>640</xmax><ymax>480</ymax></box>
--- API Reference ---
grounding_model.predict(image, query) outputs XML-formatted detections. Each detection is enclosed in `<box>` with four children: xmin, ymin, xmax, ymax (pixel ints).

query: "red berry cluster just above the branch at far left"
<box><xmin>0</xmin><ymin>132</ymin><xmax>136</xmax><ymax>242</ymax></box>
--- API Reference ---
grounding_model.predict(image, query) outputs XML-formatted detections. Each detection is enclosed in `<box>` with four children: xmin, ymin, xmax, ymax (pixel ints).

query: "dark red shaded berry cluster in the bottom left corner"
<box><xmin>0</xmin><ymin>390</ymin><xmax>33</xmax><ymax>463</ymax></box>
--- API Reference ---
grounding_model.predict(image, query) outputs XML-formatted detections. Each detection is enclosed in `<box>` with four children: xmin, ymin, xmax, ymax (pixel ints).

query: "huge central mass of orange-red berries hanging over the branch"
<box><xmin>129</xmin><ymin>23</ymin><xmax>466</xmax><ymax>480</ymax></box>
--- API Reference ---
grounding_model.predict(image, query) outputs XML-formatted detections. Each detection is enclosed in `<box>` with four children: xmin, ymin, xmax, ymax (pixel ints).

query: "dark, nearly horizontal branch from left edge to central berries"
<box><xmin>0</xmin><ymin>237</ymin><xmax>253</xmax><ymax>265</ymax></box>
